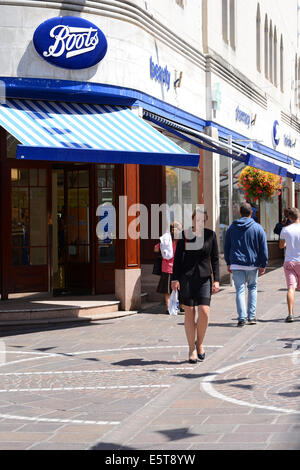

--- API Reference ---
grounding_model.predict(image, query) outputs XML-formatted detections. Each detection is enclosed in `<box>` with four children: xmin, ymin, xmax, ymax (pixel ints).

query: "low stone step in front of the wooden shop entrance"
<box><xmin>0</xmin><ymin>293</ymin><xmax>137</xmax><ymax>328</ymax></box>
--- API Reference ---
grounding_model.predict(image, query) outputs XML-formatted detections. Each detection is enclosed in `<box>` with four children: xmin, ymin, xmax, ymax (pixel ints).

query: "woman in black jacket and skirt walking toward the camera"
<box><xmin>172</xmin><ymin>208</ymin><xmax>219</xmax><ymax>364</ymax></box>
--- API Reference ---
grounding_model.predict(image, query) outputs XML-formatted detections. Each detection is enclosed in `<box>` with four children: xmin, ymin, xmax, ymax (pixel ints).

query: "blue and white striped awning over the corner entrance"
<box><xmin>0</xmin><ymin>99</ymin><xmax>199</xmax><ymax>167</ymax></box>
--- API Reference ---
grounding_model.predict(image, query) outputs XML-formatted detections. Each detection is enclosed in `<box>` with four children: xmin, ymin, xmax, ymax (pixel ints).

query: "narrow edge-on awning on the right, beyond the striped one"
<box><xmin>145</xmin><ymin>111</ymin><xmax>300</xmax><ymax>182</ymax></box>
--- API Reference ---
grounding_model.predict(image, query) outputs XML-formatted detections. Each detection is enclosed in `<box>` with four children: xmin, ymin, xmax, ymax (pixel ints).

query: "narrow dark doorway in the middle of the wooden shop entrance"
<box><xmin>52</xmin><ymin>166</ymin><xmax>92</xmax><ymax>294</ymax></box>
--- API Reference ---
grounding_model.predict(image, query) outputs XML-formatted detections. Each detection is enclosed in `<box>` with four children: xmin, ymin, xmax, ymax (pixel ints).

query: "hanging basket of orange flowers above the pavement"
<box><xmin>238</xmin><ymin>166</ymin><xmax>282</xmax><ymax>201</ymax></box>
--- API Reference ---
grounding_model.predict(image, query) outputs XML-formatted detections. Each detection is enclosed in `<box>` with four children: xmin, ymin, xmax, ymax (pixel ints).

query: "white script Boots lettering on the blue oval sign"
<box><xmin>43</xmin><ymin>24</ymin><xmax>99</xmax><ymax>59</ymax></box>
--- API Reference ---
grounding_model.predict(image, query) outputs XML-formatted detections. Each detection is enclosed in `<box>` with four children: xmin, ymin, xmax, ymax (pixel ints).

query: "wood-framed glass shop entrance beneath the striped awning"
<box><xmin>0</xmin><ymin>127</ymin><xmax>119</xmax><ymax>300</ymax></box>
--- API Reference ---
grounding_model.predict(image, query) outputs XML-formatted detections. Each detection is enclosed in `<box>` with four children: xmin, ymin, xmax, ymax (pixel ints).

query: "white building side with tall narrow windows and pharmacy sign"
<box><xmin>203</xmin><ymin>0</ymin><xmax>300</xmax><ymax>264</ymax></box>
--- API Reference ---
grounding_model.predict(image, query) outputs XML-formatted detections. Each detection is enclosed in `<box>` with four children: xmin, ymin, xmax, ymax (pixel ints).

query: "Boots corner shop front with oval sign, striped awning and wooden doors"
<box><xmin>0</xmin><ymin>5</ymin><xmax>300</xmax><ymax>310</ymax></box>
